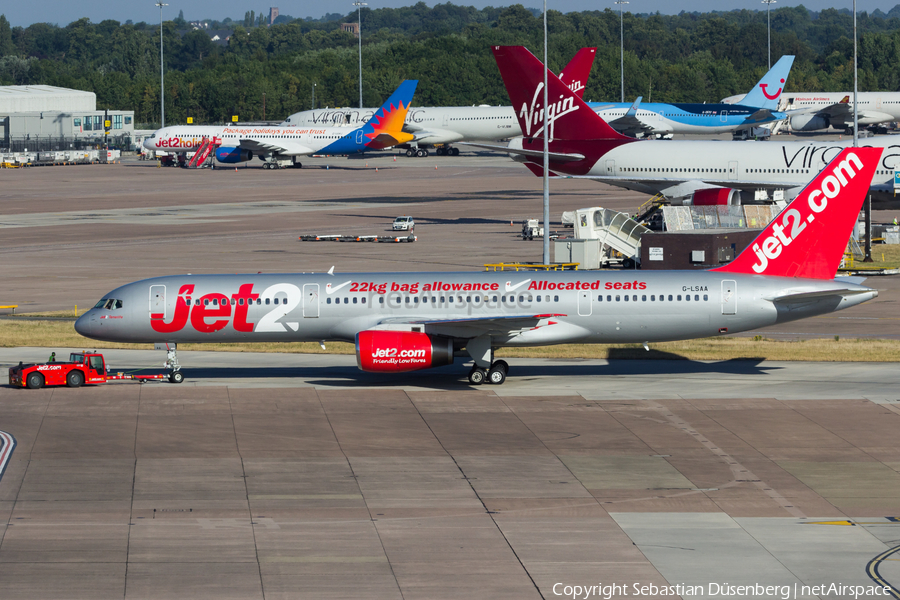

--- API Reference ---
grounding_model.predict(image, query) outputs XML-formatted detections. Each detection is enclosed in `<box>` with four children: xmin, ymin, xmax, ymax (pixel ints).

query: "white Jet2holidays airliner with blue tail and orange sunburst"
<box><xmin>144</xmin><ymin>80</ymin><xmax>418</xmax><ymax>168</ymax></box>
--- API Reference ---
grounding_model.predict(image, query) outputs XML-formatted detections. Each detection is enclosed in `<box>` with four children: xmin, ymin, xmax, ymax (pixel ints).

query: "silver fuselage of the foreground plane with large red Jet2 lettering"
<box><xmin>75</xmin><ymin>271</ymin><xmax>878</xmax><ymax>347</ymax></box>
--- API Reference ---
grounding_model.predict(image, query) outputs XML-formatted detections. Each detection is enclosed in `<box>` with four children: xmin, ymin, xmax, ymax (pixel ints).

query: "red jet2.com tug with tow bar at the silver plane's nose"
<box><xmin>9</xmin><ymin>352</ymin><xmax>184</xmax><ymax>389</ymax></box>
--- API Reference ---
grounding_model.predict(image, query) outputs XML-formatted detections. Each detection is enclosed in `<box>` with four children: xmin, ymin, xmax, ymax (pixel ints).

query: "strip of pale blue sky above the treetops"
<box><xmin>0</xmin><ymin>0</ymin><xmax>900</xmax><ymax>26</ymax></box>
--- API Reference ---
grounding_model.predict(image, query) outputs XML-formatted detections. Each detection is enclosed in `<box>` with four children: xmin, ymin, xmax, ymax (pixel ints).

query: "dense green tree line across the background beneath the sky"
<box><xmin>0</xmin><ymin>2</ymin><xmax>900</xmax><ymax>127</ymax></box>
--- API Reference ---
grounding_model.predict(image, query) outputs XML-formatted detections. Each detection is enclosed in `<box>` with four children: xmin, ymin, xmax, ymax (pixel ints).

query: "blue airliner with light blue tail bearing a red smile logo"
<box><xmin>587</xmin><ymin>56</ymin><xmax>794</xmax><ymax>136</ymax></box>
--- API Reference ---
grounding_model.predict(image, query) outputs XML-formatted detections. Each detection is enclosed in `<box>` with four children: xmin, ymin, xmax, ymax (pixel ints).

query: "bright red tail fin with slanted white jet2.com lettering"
<box><xmin>711</xmin><ymin>148</ymin><xmax>884</xmax><ymax>279</ymax></box>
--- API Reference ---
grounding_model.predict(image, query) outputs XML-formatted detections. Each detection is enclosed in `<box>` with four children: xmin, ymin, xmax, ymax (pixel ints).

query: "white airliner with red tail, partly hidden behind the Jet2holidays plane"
<box><xmin>281</xmin><ymin>48</ymin><xmax>597</xmax><ymax>157</ymax></box>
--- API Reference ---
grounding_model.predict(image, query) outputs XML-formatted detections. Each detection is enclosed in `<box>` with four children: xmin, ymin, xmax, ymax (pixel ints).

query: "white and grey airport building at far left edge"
<box><xmin>0</xmin><ymin>85</ymin><xmax>134</xmax><ymax>152</ymax></box>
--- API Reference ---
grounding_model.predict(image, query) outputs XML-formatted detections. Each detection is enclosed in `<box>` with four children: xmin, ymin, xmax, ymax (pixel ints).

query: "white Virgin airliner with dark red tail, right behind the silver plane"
<box><xmin>486</xmin><ymin>46</ymin><xmax>900</xmax><ymax>209</ymax></box>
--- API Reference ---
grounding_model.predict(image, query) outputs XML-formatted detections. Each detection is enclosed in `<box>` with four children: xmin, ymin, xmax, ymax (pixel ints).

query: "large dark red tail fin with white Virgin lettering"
<box><xmin>493</xmin><ymin>46</ymin><xmax>633</xmax><ymax>141</ymax></box>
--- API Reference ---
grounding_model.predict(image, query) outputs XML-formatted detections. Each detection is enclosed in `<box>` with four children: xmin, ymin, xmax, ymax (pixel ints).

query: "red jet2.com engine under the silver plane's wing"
<box><xmin>356</xmin><ymin>330</ymin><xmax>453</xmax><ymax>373</ymax></box>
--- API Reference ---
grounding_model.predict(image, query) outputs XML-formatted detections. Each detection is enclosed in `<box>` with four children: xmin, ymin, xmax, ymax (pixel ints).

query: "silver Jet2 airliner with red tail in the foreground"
<box><xmin>75</xmin><ymin>148</ymin><xmax>882</xmax><ymax>384</ymax></box>
